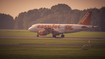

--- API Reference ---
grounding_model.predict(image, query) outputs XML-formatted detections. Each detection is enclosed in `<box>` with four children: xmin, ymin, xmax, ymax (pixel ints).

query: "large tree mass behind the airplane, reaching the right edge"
<box><xmin>0</xmin><ymin>4</ymin><xmax>105</xmax><ymax>32</ymax></box>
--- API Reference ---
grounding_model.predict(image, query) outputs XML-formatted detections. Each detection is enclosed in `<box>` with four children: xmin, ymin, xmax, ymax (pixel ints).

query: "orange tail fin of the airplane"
<box><xmin>78</xmin><ymin>11</ymin><xmax>92</xmax><ymax>25</ymax></box>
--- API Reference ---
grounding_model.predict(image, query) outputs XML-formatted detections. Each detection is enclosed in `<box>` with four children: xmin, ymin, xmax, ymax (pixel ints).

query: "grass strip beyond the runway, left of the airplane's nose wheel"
<box><xmin>0</xmin><ymin>30</ymin><xmax>37</xmax><ymax>36</ymax></box>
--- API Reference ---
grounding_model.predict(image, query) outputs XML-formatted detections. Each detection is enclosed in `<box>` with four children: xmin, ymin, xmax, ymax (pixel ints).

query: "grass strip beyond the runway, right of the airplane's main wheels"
<box><xmin>66</xmin><ymin>32</ymin><xmax>105</xmax><ymax>38</ymax></box>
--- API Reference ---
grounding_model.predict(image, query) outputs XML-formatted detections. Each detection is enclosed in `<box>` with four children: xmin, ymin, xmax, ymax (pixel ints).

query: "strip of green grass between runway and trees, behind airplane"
<box><xmin>0</xmin><ymin>29</ymin><xmax>105</xmax><ymax>38</ymax></box>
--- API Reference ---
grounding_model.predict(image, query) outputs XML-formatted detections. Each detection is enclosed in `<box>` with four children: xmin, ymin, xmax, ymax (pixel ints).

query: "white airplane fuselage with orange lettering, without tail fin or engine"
<box><xmin>28</xmin><ymin>24</ymin><xmax>92</xmax><ymax>34</ymax></box>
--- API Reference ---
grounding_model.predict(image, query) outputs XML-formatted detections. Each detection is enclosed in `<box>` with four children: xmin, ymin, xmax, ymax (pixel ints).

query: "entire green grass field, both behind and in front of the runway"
<box><xmin>0</xmin><ymin>30</ymin><xmax>105</xmax><ymax>59</ymax></box>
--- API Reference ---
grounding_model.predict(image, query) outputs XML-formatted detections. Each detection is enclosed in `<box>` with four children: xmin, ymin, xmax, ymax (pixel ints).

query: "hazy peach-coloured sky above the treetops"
<box><xmin>0</xmin><ymin>0</ymin><xmax>105</xmax><ymax>18</ymax></box>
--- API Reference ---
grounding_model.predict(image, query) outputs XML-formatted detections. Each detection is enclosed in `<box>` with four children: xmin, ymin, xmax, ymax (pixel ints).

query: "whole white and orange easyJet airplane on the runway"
<box><xmin>28</xmin><ymin>11</ymin><xmax>97</xmax><ymax>38</ymax></box>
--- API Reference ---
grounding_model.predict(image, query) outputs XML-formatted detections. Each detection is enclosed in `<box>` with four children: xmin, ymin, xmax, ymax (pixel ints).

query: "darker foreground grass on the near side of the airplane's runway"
<box><xmin>0</xmin><ymin>38</ymin><xmax>105</xmax><ymax>59</ymax></box>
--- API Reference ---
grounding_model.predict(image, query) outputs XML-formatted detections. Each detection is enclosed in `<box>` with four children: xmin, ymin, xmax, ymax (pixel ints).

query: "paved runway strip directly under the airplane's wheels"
<box><xmin>0</xmin><ymin>36</ymin><xmax>105</xmax><ymax>40</ymax></box>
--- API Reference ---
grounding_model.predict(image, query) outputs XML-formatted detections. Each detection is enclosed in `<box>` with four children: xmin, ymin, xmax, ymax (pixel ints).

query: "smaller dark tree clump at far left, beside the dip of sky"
<box><xmin>0</xmin><ymin>14</ymin><xmax>15</xmax><ymax>29</ymax></box>
